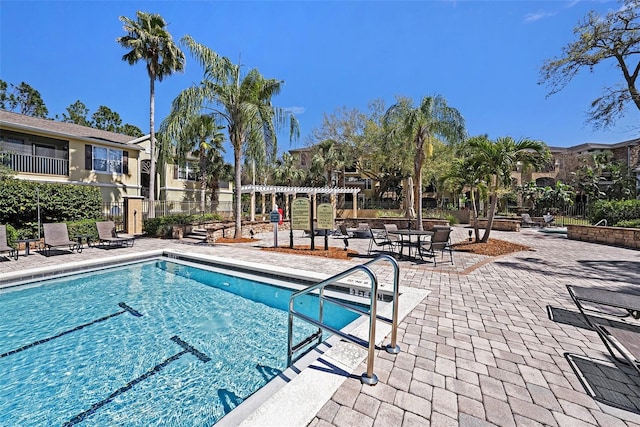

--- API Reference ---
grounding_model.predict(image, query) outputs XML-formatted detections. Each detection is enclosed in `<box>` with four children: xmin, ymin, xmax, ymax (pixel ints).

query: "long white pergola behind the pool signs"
<box><xmin>240</xmin><ymin>184</ymin><xmax>360</xmax><ymax>221</ymax></box>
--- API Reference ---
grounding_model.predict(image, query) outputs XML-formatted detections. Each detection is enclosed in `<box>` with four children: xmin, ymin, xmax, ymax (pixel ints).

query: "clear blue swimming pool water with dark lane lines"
<box><xmin>0</xmin><ymin>261</ymin><xmax>356</xmax><ymax>426</ymax></box>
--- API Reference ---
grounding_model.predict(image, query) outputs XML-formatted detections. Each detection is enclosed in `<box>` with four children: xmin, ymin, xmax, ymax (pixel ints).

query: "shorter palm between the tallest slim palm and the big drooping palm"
<box><xmin>160</xmin><ymin>110</ymin><xmax>224</xmax><ymax>212</ymax></box>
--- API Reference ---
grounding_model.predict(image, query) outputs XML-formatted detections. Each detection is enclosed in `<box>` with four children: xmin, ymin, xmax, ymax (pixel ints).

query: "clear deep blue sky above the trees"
<box><xmin>0</xmin><ymin>0</ymin><xmax>639</xmax><ymax>154</ymax></box>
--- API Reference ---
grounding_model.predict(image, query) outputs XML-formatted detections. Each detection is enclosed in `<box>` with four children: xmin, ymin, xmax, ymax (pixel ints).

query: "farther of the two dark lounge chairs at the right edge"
<box><xmin>567</xmin><ymin>285</ymin><xmax>640</xmax><ymax>327</ymax></box>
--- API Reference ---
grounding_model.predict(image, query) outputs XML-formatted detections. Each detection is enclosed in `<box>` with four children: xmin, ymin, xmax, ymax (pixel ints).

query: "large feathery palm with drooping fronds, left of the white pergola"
<box><xmin>172</xmin><ymin>36</ymin><xmax>299</xmax><ymax>238</ymax></box>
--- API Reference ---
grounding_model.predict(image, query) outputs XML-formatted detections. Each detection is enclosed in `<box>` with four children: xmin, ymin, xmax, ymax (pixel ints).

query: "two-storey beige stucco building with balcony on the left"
<box><xmin>0</xmin><ymin>110</ymin><xmax>233</xmax><ymax>212</ymax></box>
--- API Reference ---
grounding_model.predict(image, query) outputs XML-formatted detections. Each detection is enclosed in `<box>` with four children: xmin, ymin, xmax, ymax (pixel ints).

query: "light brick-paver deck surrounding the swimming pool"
<box><xmin>0</xmin><ymin>226</ymin><xmax>640</xmax><ymax>426</ymax></box>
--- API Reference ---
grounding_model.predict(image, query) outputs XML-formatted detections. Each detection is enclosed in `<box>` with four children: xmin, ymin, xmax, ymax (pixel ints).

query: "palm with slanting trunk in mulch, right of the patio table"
<box><xmin>468</xmin><ymin>136</ymin><xmax>550</xmax><ymax>243</ymax></box>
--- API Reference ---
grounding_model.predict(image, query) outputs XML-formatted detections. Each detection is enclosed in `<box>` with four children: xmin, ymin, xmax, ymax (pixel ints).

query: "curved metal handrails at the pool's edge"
<box><xmin>287</xmin><ymin>255</ymin><xmax>400</xmax><ymax>385</ymax></box>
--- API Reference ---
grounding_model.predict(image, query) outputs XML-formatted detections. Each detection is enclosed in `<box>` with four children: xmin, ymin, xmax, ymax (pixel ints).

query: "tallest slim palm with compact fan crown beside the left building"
<box><xmin>116</xmin><ymin>11</ymin><xmax>185</xmax><ymax>218</ymax></box>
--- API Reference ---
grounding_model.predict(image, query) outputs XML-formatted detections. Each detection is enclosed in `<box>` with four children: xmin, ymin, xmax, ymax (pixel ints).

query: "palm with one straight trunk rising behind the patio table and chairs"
<box><xmin>384</xmin><ymin>96</ymin><xmax>465</xmax><ymax>230</ymax></box>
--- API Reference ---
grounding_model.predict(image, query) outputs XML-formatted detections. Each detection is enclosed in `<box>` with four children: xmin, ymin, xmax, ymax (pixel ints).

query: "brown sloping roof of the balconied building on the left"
<box><xmin>0</xmin><ymin>110</ymin><xmax>142</xmax><ymax>149</ymax></box>
